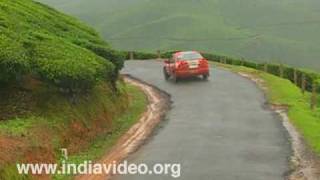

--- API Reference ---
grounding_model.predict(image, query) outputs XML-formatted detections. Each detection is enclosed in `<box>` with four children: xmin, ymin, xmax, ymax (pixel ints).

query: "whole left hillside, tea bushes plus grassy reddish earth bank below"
<box><xmin>0</xmin><ymin>0</ymin><xmax>147</xmax><ymax>180</ymax></box>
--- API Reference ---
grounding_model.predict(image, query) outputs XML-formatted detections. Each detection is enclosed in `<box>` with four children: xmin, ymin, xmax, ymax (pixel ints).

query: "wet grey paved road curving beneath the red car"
<box><xmin>115</xmin><ymin>61</ymin><xmax>291</xmax><ymax>180</ymax></box>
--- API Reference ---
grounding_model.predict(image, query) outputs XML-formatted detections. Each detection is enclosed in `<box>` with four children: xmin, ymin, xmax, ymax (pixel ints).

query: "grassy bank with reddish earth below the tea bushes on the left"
<box><xmin>0</xmin><ymin>82</ymin><xmax>147</xmax><ymax>179</ymax></box>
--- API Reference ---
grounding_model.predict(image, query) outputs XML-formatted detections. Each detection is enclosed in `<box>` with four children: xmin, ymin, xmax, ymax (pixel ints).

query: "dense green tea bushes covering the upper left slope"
<box><xmin>0</xmin><ymin>0</ymin><xmax>124</xmax><ymax>92</ymax></box>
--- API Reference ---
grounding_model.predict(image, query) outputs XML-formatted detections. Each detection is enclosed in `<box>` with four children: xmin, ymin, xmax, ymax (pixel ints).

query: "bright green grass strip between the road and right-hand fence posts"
<box><xmin>212</xmin><ymin>62</ymin><xmax>320</xmax><ymax>156</ymax></box>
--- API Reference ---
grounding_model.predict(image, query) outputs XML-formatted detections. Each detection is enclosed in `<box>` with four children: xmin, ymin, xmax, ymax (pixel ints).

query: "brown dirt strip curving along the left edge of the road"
<box><xmin>75</xmin><ymin>76</ymin><xmax>171</xmax><ymax>180</ymax></box>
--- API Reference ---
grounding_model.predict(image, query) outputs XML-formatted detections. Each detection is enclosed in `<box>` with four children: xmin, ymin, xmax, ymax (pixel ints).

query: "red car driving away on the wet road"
<box><xmin>163</xmin><ymin>51</ymin><xmax>210</xmax><ymax>82</ymax></box>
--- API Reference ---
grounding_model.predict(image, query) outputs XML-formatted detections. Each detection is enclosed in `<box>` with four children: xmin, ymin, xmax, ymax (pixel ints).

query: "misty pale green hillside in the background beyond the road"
<box><xmin>41</xmin><ymin>0</ymin><xmax>320</xmax><ymax>70</ymax></box>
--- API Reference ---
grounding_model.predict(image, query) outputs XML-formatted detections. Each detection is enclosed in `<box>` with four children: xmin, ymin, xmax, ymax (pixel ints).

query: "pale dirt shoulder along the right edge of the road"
<box><xmin>238</xmin><ymin>72</ymin><xmax>320</xmax><ymax>180</ymax></box>
